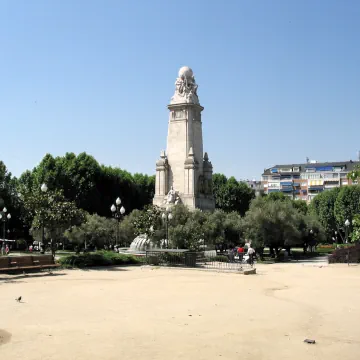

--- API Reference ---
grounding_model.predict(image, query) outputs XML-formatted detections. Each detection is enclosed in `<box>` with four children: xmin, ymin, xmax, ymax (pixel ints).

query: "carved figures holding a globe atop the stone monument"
<box><xmin>171</xmin><ymin>66</ymin><xmax>199</xmax><ymax>104</ymax></box>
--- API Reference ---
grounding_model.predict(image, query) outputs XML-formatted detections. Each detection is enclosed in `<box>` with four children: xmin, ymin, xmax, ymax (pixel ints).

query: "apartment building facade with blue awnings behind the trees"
<box><xmin>261</xmin><ymin>160</ymin><xmax>360</xmax><ymax>202</ymax></box>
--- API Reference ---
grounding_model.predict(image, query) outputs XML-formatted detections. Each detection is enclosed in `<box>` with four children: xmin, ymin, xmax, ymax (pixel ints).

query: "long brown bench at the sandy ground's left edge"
<box><xmin>0</xmin><ymin>255</ymin><xmax>60</xmax><ymax>273</ymax></box>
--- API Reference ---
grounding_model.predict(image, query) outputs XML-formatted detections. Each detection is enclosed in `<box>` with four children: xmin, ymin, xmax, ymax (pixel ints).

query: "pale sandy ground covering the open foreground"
<box><xmin>0</xmin><ymin>264</ymin><xmax>360</xmax><ymax>360</ymax></box>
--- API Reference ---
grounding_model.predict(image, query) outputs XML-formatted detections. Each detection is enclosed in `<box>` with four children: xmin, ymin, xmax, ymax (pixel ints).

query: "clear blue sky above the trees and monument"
<box><xmin>0</xmin><ymin>0</ymin><xmax>360</xmax><ymax>178</ymax></box>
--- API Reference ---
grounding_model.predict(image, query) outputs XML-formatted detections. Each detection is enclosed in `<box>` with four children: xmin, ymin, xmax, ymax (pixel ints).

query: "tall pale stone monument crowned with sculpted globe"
<box><xmin>153</xmin><ymin>66</ymin><xmax>215</xmax><ymax>210</ymax></box>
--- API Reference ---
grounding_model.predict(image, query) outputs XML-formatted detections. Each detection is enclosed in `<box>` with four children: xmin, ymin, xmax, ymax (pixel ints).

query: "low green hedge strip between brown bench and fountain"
<box><xmin>59</xmin><ymin>251</ymin><xmax>143</xmax><ymax>268</ymax></box>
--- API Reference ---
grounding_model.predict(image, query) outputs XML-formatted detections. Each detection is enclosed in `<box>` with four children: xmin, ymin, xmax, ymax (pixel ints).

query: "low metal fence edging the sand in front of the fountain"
<box><xmin>146</xmin><ymin>249</ymin><xmax>255</xmax><ymax>272</ymax></box>
